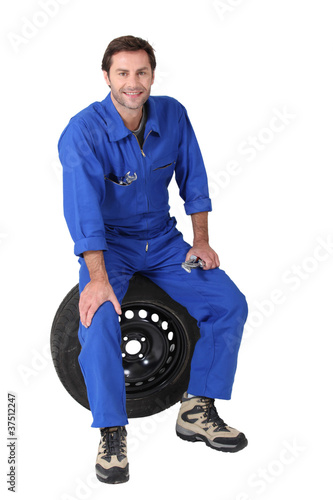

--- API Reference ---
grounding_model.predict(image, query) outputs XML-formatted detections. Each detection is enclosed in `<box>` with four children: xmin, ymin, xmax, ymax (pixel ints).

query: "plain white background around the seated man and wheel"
<box><xmin>0</xmin><ymin>0</ymin><xmax>333</xmax><ymax>500</ymax></box>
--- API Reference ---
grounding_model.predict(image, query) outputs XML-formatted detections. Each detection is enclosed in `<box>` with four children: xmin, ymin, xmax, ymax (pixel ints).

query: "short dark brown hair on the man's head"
<box><xmin>102</xmin><ymin>35</ymin><xmax>156</xmax><ymax>73</ymax></box>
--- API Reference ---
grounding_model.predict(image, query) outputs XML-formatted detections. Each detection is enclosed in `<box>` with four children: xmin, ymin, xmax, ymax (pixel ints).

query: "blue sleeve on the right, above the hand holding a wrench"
<box><xmin>175</xmin><ymin>106</ymin><xmax>212</xmax><ymax>215</ymax></box>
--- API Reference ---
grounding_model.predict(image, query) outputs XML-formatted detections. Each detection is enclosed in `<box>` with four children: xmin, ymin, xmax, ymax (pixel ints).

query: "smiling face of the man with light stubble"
<box><xmin>103</xmin><ymin>50</ymin><xmax>154</xmax><ymax>109</ymax></box>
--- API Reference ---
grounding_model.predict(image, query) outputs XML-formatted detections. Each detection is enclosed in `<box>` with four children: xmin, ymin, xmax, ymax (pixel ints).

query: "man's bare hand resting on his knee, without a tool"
<box><xmin>79</xmin><ymin>280</ymin><xmax>121</xmax><ymax>328</ymax></box>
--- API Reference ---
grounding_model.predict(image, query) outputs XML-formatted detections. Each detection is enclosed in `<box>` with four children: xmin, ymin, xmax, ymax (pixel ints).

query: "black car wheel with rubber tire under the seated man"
<box><xmin>51</xmin><ymin>273</ymin><xmax>200</xmax><ymax>418</ymax></box>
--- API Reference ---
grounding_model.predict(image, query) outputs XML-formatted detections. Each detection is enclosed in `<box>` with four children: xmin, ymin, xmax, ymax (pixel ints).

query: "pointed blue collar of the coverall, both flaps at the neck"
<box><xmin>101</xmin><ymin>93</ymin><xmax>160</xmax><ymax>141</ymax></box>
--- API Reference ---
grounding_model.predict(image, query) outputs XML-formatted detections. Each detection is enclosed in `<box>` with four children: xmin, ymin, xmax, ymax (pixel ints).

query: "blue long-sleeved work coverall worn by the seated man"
<box><xmin>58</xmin><ymin>94</ymin><xmax>247</xmax><ymax>427</ymax></box>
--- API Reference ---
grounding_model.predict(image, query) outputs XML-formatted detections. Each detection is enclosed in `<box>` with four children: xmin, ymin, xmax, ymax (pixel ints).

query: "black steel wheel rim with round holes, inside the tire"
<box><xmin>119</xmin><ymin>302</ymin><xmax>186</xmax><ymax>398</ymax></box>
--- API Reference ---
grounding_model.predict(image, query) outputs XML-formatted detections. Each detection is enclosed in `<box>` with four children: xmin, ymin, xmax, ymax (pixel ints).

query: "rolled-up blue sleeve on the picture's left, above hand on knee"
<box><xmin>58</xmin><ymin>120</ymin><xmax>108</xmax><ymax>257</ymax></box>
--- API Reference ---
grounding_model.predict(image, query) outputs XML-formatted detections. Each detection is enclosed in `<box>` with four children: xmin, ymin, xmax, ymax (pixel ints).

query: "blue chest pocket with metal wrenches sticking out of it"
<box><xmin>103</xmin><ymin>166</ymin><xmax>138</xmax><ymax>219</ymax></box>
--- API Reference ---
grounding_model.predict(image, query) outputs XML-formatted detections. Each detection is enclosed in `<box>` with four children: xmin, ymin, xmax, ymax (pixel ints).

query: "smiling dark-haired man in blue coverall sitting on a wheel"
<box><xmin>59</xmin><ymin>36</ymin><xmax>247</xmax><ymax>483</ymax></box>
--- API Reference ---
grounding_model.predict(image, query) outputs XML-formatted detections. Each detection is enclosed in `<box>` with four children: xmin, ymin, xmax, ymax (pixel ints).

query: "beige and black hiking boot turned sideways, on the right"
<box><xmin>176</xmin><ymin>393</ymin><xmax>247</xmax><ymax>452</ymax></box>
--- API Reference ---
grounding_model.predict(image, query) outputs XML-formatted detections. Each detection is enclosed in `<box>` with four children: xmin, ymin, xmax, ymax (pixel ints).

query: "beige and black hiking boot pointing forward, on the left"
<box><xmin>96</xmin><ymin>427</ymin><xmax>129</xmax><ymax>484</ymax></box>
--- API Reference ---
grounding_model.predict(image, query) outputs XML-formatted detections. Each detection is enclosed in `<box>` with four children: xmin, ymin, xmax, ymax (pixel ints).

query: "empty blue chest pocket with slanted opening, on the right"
<box><xmin>149</xmin><ymin>151</ymin><xmax>178</xmax><ymax>210</ymax></box>
